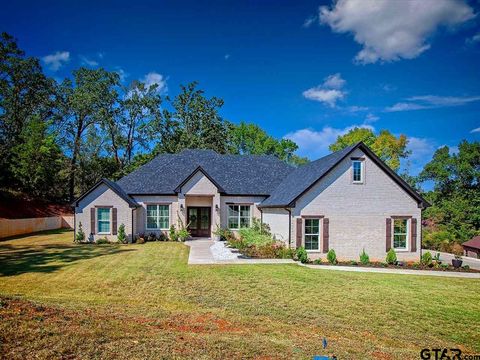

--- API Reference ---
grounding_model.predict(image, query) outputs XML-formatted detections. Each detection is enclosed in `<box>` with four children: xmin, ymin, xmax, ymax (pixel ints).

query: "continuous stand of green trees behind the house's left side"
<box><xmin>0</xmin><ymin>33</ymin><xmax>307</xmax><ymax>201</ymax></box>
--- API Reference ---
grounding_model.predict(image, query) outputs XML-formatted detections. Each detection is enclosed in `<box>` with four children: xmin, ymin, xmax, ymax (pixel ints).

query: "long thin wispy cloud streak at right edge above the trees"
<box><xmin>385</xmin><ymin>95</ymin><xmax>480</xmax><ymax>112</ymax></box>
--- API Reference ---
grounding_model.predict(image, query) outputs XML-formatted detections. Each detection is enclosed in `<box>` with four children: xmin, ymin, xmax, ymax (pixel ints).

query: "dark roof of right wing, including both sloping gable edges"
<box><xmin>260</xmin><ymin>142</ymin><xmax>430</xmax><ymax>207</ymax></box>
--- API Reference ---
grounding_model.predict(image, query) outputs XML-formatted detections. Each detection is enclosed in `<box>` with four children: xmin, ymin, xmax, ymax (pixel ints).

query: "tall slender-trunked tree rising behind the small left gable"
<box><xmin>57</xmin><ymin>68</ymin><xmax>119</xmax><ymax>201</ymax></box>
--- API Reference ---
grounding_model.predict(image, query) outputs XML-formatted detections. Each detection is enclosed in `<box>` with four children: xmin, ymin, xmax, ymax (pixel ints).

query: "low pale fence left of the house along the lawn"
<box><xmin>0</xmin><ymin>216</ymin><xmax>73</xmax><ymax>238</ymax></box>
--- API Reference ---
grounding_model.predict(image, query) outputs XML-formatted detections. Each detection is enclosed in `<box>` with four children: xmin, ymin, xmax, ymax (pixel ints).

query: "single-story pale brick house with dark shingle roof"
<box><xmin>75</xmin><ymin>143</ymin><xmax>429</xmax><ymax>260</ymax></box>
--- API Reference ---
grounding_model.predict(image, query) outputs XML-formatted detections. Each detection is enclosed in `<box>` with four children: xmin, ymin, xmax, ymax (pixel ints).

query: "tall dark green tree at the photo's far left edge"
<box><xmin>0</xmin><ymin>33</ymin><xmax>55</xmax><ymax>185</ymax></box>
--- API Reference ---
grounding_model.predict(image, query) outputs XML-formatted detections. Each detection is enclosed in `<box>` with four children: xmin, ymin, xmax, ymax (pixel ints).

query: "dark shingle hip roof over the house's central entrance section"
<box><xmin>117</xmin><ymin>150</ymin><xmax>295</xmax><ymax>195</ymax></box>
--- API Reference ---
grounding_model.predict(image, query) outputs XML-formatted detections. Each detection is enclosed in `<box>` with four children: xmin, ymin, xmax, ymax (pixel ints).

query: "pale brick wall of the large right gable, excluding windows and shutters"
<box><xmin>292</xmin><ymin>150</ymin><xmax>421</xmax><ymax>261</ymax></box>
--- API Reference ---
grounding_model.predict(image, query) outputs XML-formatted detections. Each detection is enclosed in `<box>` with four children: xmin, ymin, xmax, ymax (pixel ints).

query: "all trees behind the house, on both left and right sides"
<box><xmin>0</xmin><ymin>33</ymin><xmax>480</xmax><ymax>250</ymax></box>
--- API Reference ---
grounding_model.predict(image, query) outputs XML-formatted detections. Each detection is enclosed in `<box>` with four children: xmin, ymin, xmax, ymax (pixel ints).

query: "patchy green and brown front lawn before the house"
<box><xmin>0</xmin><ymin>232</ymin><xmax>480</xmax><ymax>359</ymax></box>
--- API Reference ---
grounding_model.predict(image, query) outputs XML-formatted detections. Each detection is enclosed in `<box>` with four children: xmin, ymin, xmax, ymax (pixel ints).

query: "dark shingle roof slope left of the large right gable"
<box><xmin>261</xmin><ymin>145</ymin><xmax>355</xmax><ymax>207</ymax></box>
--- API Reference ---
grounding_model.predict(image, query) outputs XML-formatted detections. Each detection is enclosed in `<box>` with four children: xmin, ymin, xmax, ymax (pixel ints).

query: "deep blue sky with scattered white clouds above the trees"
<box><xmin>0</xmin><ymin>0</ymin><xmax>480</xmax><ymax>173</ymax></box>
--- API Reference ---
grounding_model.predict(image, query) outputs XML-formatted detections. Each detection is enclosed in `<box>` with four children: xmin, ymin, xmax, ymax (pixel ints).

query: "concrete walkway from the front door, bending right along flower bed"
<box><xmin>185</xmin><ymin>239</ymin><xmax>296</xmax><ymax>265</ymax></box>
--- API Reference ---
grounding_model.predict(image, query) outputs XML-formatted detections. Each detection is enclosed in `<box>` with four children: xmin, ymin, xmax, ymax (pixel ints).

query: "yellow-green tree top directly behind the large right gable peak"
<box><xmin>329</xmin><ymin>127</ymin><xmax>410</xmax><ymax>171</ymax></box>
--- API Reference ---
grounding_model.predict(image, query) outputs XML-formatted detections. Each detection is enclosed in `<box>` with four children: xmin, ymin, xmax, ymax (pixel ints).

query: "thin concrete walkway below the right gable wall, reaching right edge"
<box><xmin>299</xmin><ymin>263</ymin><xmax>480</xmax><ymax>279</ymax></box>
